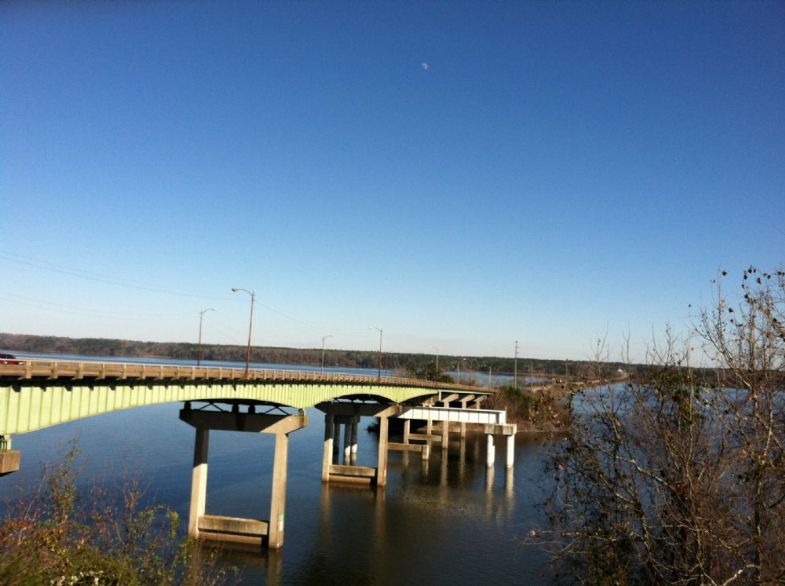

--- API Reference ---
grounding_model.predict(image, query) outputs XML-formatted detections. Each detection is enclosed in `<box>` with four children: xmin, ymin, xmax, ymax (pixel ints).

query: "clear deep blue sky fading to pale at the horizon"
<box><xmin>0</xmin><ymin>2</ymin><xmax>785</xmax><ymax>359</ymax></box>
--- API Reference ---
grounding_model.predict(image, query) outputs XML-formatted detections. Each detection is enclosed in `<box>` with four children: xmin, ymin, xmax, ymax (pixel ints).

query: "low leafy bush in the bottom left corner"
<box><xmin>0</xmin><ymin>444</ymin><xmax>232</xmax><ymax>586</ymax></box>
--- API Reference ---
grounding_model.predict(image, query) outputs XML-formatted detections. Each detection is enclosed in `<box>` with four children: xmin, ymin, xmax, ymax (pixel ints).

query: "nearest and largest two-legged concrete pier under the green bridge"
<box><xmin>180</xmin><ymin>404</ymin><xmax>308</xmax><ymax>549</ymax></box>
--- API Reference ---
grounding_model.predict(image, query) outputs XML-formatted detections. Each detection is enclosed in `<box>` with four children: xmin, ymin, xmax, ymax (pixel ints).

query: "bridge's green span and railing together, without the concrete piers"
<box><xmin>0</xmin><ymin>360</ymin><xmax>494</xmax><ymax>440</ymax></box>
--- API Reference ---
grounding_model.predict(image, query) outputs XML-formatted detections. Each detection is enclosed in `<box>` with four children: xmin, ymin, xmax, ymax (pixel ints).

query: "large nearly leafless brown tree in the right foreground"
<box><xmin>537</xmin><ymin>267</ymin><xmax>785</xmax><ymax>584</ymax></box>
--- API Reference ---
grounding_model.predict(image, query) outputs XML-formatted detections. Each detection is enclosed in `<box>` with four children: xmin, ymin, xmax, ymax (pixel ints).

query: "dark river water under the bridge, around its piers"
<box><xmin>0</xmin><ymin>358</ymin><xmax>548</xmax><ymax>585</ymax></box>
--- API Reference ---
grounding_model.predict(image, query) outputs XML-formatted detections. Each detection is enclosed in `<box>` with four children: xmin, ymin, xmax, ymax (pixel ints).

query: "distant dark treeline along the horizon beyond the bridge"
<box><xmin>0</xmin><ymin>333</ymin><xmax>645</xmax><ymax>377</ymax></box>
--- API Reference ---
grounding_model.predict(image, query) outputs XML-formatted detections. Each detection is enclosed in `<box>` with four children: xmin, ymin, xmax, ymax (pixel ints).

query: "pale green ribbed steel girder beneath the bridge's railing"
<box><xmin>0</xmin><ymin>381</ymin><xmax>436</xmax><ymax>442</ymax></box>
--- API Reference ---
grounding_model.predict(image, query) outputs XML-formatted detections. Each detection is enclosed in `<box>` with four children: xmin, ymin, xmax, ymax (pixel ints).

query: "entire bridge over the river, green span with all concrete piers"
<box><xmin>0</xmin><ymin>360</ymin><xmax>516</xmax><ymax>548</ymax></box>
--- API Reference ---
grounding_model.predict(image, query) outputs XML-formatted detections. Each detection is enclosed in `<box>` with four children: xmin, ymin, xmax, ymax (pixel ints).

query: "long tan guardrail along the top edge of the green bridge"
<box><xmin>0</xmin><ymin>359</ymin><xmax>494</xmax><ymax>394</ymax></box>
